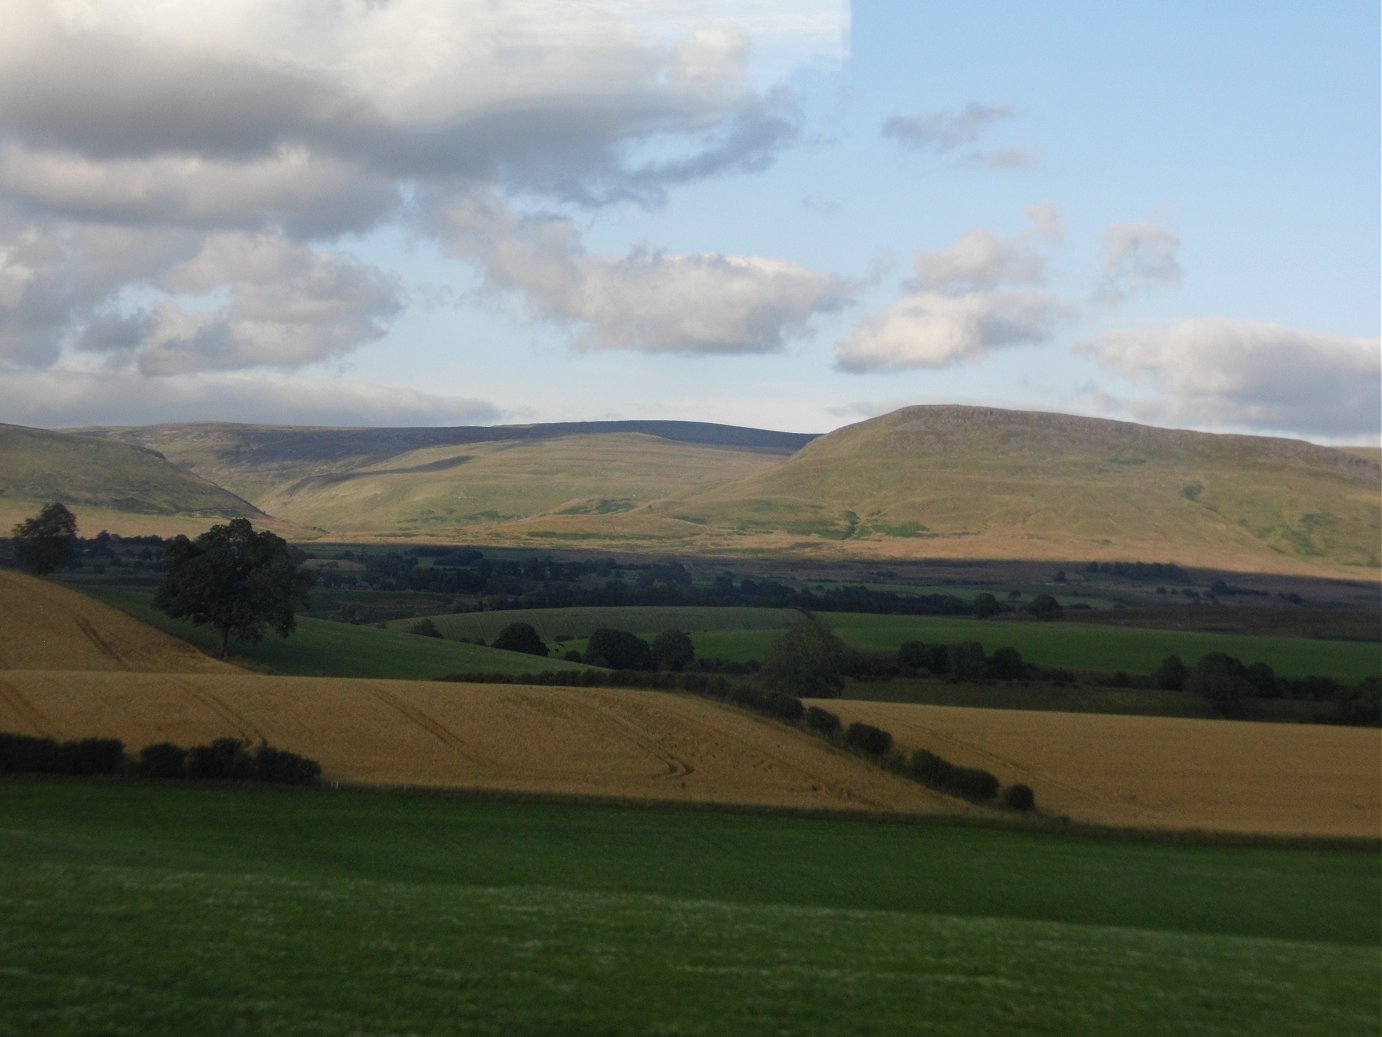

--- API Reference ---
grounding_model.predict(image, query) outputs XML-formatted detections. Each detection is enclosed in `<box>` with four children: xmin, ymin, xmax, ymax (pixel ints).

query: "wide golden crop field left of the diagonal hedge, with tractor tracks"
<box><xmin>0</xmin><ymin>671</ymin><xmax>966</xmax><ymax>813</ymax></box>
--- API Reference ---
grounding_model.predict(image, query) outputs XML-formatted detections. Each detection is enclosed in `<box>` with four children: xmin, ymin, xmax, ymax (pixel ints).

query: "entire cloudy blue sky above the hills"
<box><xmin>0</xmin><ymin>0</ymin><xmax>1382</xmax><ymax>445</ymax></box>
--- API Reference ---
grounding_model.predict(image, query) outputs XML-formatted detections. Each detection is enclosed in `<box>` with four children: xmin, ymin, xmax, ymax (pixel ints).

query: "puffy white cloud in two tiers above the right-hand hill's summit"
<box><xmin>837</xmin><ymin>203</ymin><xmax>1074</xmax><ymax>373</ymax></box>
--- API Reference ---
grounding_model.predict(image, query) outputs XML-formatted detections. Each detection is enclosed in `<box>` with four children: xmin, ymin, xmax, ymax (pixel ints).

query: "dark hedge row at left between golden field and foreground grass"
<box><xmin>0</xmin><ymin>731</ymin><xmax>322</xmax><ymax>785</ymax></box>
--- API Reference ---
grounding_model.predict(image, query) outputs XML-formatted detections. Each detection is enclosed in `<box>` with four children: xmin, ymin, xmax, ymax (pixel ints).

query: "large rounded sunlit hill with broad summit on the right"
<box><xmin>668</xmin><ymin>407</ymin><xmax>1382</xmax><ymax>574</ymax></box>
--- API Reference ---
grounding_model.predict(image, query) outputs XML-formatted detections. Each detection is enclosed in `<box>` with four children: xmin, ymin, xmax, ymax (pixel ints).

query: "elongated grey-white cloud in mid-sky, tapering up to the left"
<box><xmin>437</xmin><ymin>199</ymin><xmax>849</xmax><ymax>354</ymax></box>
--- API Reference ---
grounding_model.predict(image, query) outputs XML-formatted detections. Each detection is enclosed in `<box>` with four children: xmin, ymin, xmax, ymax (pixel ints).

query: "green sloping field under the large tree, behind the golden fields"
<box><xmin>90</xmin><ymin>589</ymin><xmax>597</xmax><ymax>680</ymax></box>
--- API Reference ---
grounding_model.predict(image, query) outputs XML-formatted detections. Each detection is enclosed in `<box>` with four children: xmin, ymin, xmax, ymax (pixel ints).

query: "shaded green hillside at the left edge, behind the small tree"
<box><xmin>0</xmin><ymin>424</ymin><xmax>263</xmax><ymax>519</ymax></box>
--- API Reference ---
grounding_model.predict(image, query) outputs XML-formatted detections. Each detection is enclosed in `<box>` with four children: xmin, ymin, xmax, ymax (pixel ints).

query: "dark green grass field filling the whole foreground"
<box><xmin>0</xmin><ymin>781</ymin><xmax>1382</xmax><ymax>1037</ymax></box>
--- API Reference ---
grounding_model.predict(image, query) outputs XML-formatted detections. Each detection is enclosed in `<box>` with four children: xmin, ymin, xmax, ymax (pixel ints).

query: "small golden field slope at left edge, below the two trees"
<box><xmin>0</xmin><ymin>570</ymin><xmax>234</xmax><ymax>673</ymax></box>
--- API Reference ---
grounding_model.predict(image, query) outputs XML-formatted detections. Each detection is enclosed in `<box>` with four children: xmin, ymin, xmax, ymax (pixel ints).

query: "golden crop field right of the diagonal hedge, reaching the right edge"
<box><xmin>821</xmin><ymin>701</ymin><xmax>1382</xmax><ymax>839</ymax></box>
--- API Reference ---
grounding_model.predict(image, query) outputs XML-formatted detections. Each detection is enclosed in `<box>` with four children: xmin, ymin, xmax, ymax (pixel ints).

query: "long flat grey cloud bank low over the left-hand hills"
<box><xmin>0</xmin><ymin>368</ymin><xmax>503</xmax><ymax>427</ymax></box>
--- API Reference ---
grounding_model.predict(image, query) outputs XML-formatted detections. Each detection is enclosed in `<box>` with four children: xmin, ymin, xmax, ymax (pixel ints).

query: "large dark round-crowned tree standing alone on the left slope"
<box><xmin>153</xmin><ymin>519</ymin><xmax>312</xmax><ymax>658</ymax></box>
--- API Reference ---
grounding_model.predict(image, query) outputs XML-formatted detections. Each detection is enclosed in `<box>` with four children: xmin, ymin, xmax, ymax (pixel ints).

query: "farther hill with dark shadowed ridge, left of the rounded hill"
<box><xmin>82</xmin><ymin>422</ymin><xmax>813</xmax><ymax>536</ymax></box>
